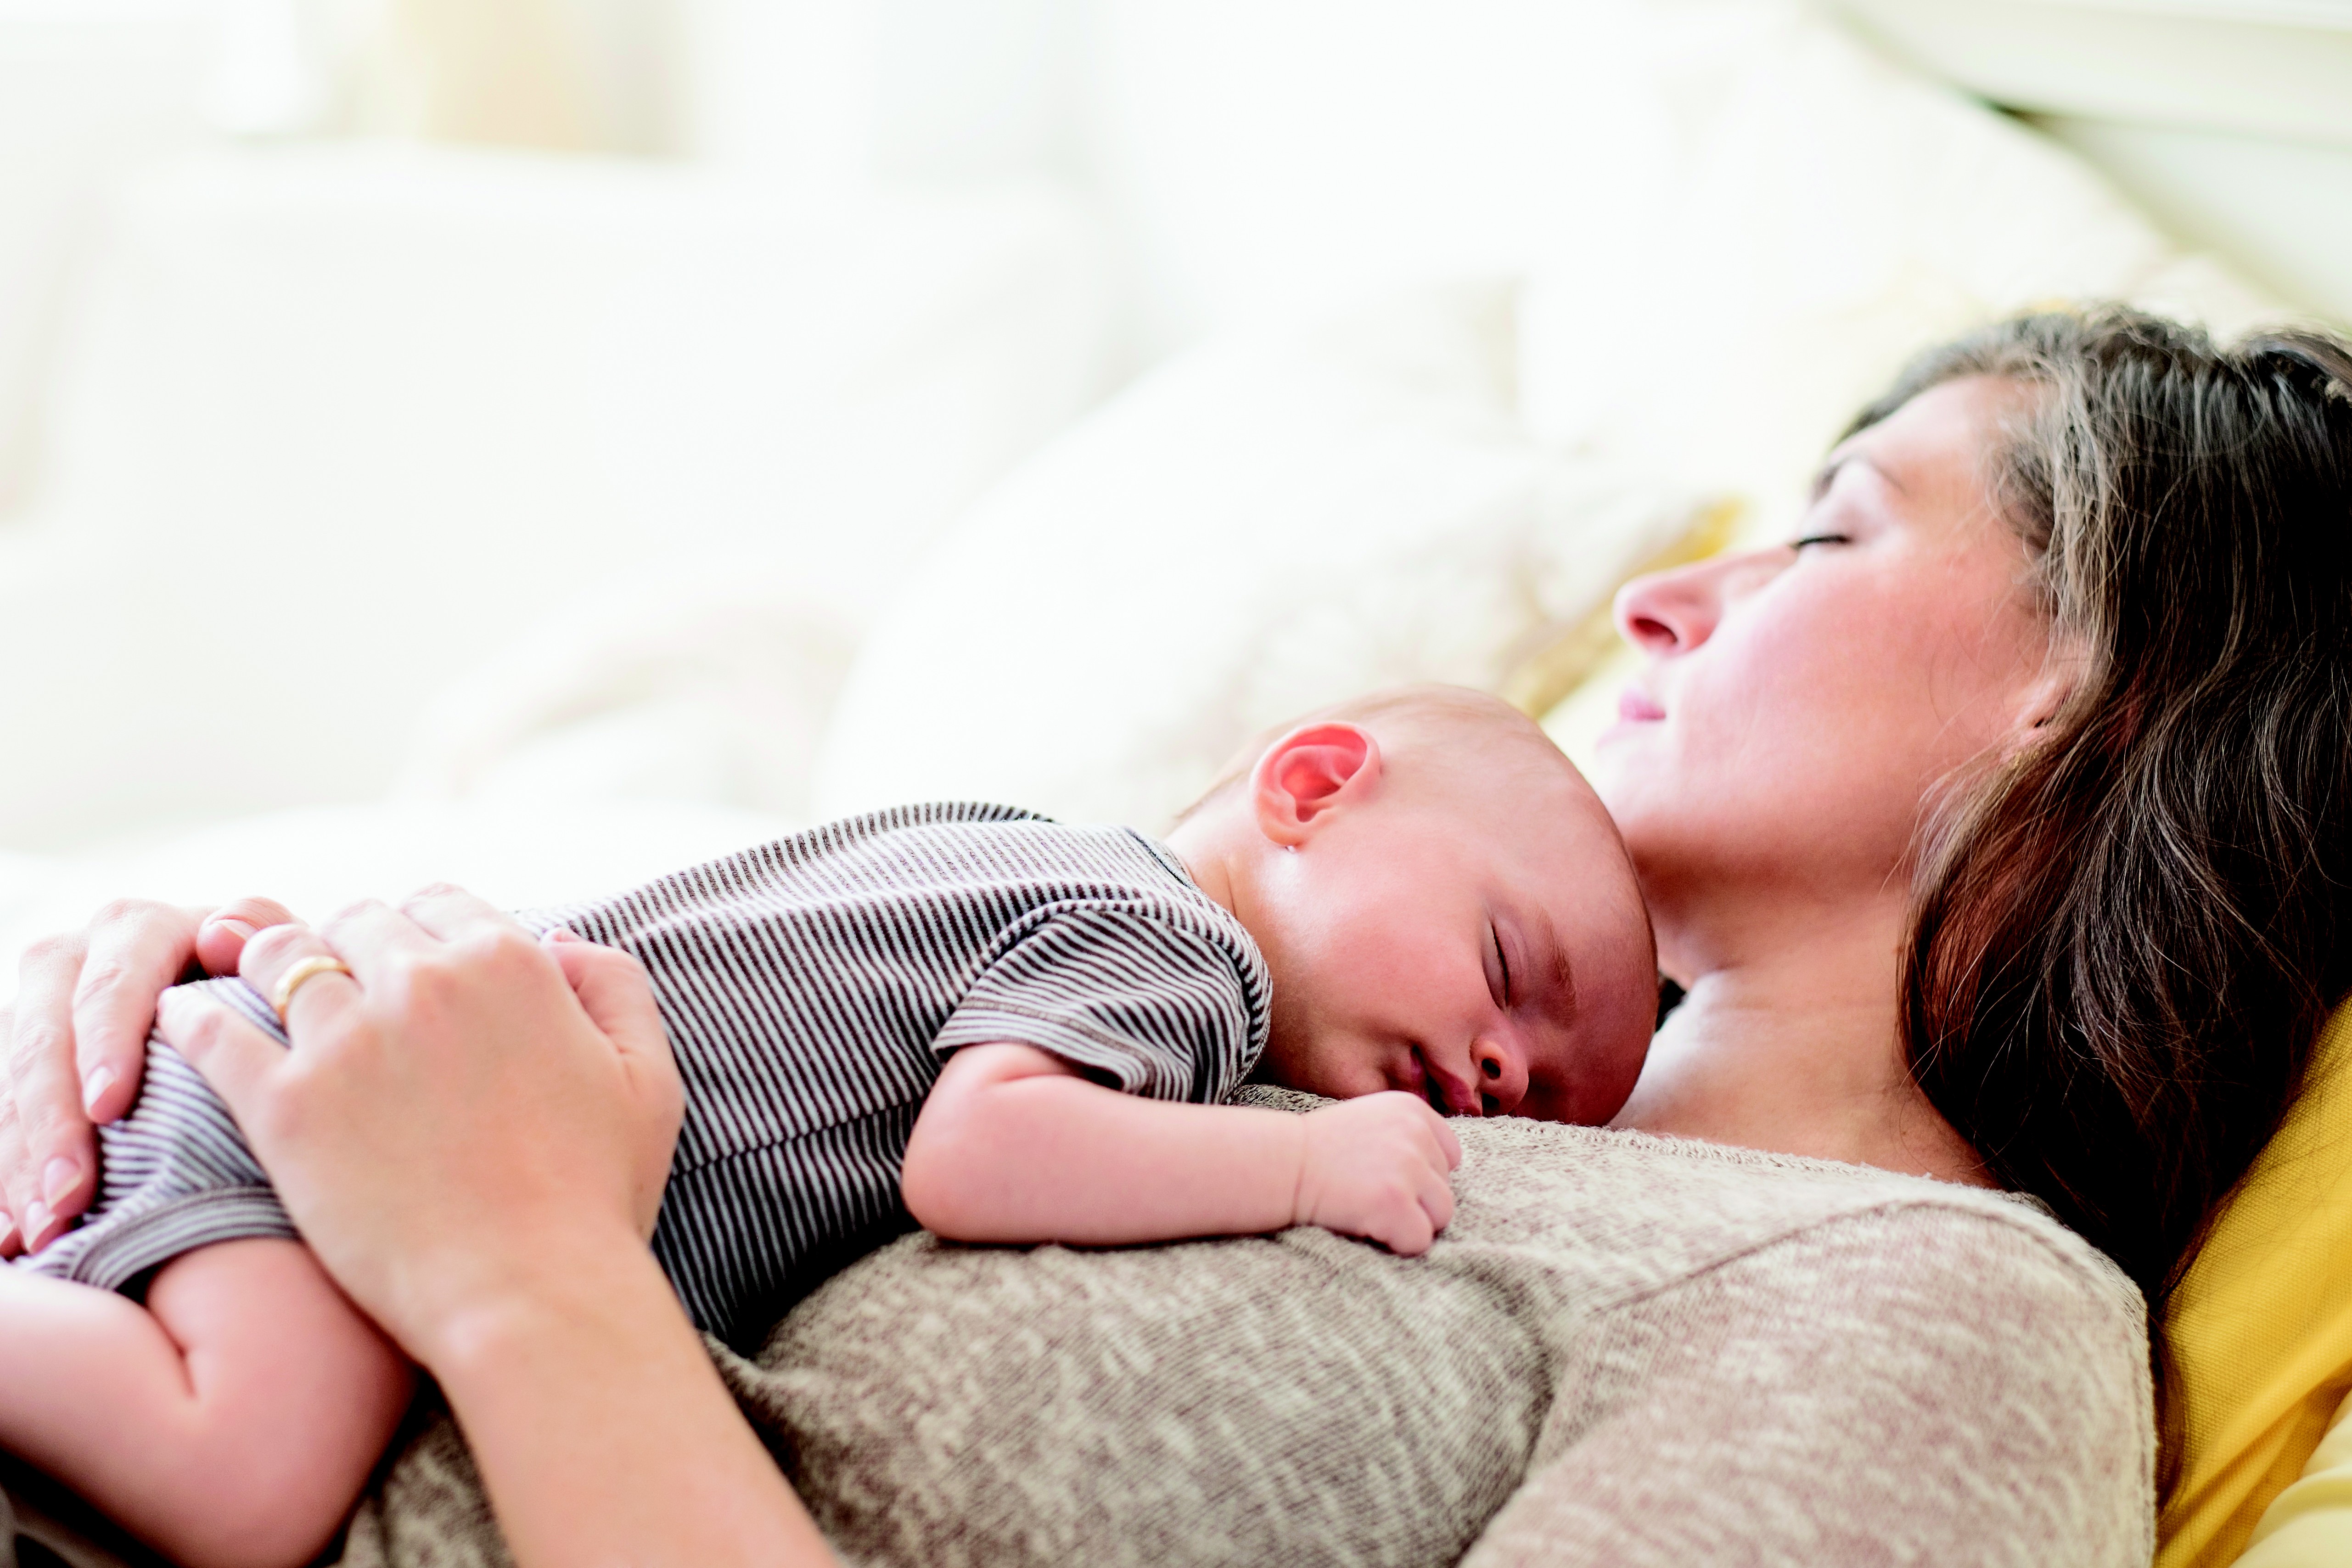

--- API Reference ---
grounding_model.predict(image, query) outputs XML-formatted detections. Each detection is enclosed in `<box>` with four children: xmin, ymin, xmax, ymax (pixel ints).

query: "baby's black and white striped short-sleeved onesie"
<box><xmin>26</xmin><ymin>804</ymin><xmax>1268</xmax><ymax>1340</ymax></box>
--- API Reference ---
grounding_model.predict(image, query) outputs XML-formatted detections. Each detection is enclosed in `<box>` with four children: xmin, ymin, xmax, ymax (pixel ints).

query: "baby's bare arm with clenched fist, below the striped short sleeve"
<box><xmin>901</xmin><ymin>1044</ymin><xmax>1460</xmax><ymax>1255</ymax></box>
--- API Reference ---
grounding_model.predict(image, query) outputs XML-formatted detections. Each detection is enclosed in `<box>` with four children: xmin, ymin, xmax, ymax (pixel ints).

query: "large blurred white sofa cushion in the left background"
<box><xmin>0</xmin><ymin>146</ymin><xmax>1108</xmax><ymax>846</ymax></box>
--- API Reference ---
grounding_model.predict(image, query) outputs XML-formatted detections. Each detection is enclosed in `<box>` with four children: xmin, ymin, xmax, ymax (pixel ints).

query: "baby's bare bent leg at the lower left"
<box><xmin>0</xmin><ymin>1239</ymin><xmax>412</xmax><ymax>1568</ymax></box>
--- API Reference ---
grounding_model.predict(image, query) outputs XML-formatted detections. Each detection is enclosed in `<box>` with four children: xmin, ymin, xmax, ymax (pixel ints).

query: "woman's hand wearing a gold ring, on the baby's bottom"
<box><xmin>162</xmin><ymin>886</ymin><xmax>685</xmax><ymax>1364</ymax></box>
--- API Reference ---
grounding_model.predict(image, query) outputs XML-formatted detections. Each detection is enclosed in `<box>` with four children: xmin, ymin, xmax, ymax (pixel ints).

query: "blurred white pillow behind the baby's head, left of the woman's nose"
<box><xmin>814</xmin><ymin>287</ymin><xmax>1696</xmax><ymax>827</ymax></box>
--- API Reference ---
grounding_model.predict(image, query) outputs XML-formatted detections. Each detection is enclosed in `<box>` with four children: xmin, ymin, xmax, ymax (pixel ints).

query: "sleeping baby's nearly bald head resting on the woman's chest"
<box><xmin>1171</xmin><ymin>686</ymin><xmax>1658</xmax><ymax>1124</ymax></box>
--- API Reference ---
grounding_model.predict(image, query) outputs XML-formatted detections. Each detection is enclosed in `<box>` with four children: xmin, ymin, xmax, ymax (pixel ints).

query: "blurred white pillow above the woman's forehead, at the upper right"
<box><xmin>1519</xmin><ymin>0</ymin><xmax>2274</xmax><ymax>540</ymax></box>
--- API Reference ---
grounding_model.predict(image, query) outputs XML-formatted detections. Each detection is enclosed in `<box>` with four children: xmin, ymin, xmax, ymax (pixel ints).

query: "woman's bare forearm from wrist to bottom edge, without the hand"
<box><xmin>421</xmin><ymin>1243</ymin><xmax>833</xmax><ymax>1568</ymax></box>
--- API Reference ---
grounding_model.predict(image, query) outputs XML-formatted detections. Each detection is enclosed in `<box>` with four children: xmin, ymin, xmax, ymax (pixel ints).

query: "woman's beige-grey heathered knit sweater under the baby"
<box><xmin>327</xmin><ymin>1089</ymin><xmax>2155</xmax><ymax>1568</ymax></box>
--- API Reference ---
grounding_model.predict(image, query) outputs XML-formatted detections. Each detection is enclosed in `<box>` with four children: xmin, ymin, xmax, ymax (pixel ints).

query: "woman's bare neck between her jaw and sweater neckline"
<box><xmin>1616</xmin><ymin>900</ymin><xmax>1990</xmax><ymax>1185</ymax></box>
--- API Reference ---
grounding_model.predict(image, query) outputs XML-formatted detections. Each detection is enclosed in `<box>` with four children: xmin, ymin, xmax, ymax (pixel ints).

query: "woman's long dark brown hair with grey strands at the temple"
<box><xmin>1856</xmin><ymin>308</ymin><xmax>2352</xmax><ymax>1485</ymax></box>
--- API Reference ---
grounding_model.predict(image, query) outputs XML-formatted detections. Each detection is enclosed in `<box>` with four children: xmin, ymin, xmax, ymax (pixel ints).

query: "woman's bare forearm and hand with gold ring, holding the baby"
<box><xmin>162</xmin><ymin>888</ymin><xmax>833</xmax><ymax>1568</ymax></box>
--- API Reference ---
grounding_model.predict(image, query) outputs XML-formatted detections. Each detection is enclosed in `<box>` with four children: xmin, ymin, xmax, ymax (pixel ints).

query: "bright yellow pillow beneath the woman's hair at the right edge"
<box><xmin>2157</xmin><ymin>1004</ymin><xmax>2352</xmax><ymax>1568</ymax></box>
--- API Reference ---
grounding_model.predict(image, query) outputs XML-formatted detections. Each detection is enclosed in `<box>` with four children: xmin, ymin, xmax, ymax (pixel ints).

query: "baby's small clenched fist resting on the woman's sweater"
<box><xmin>1291</xmin><ymin>1089</ymin><xmax>1463</xmax><ymax>1258</ymax></box>
